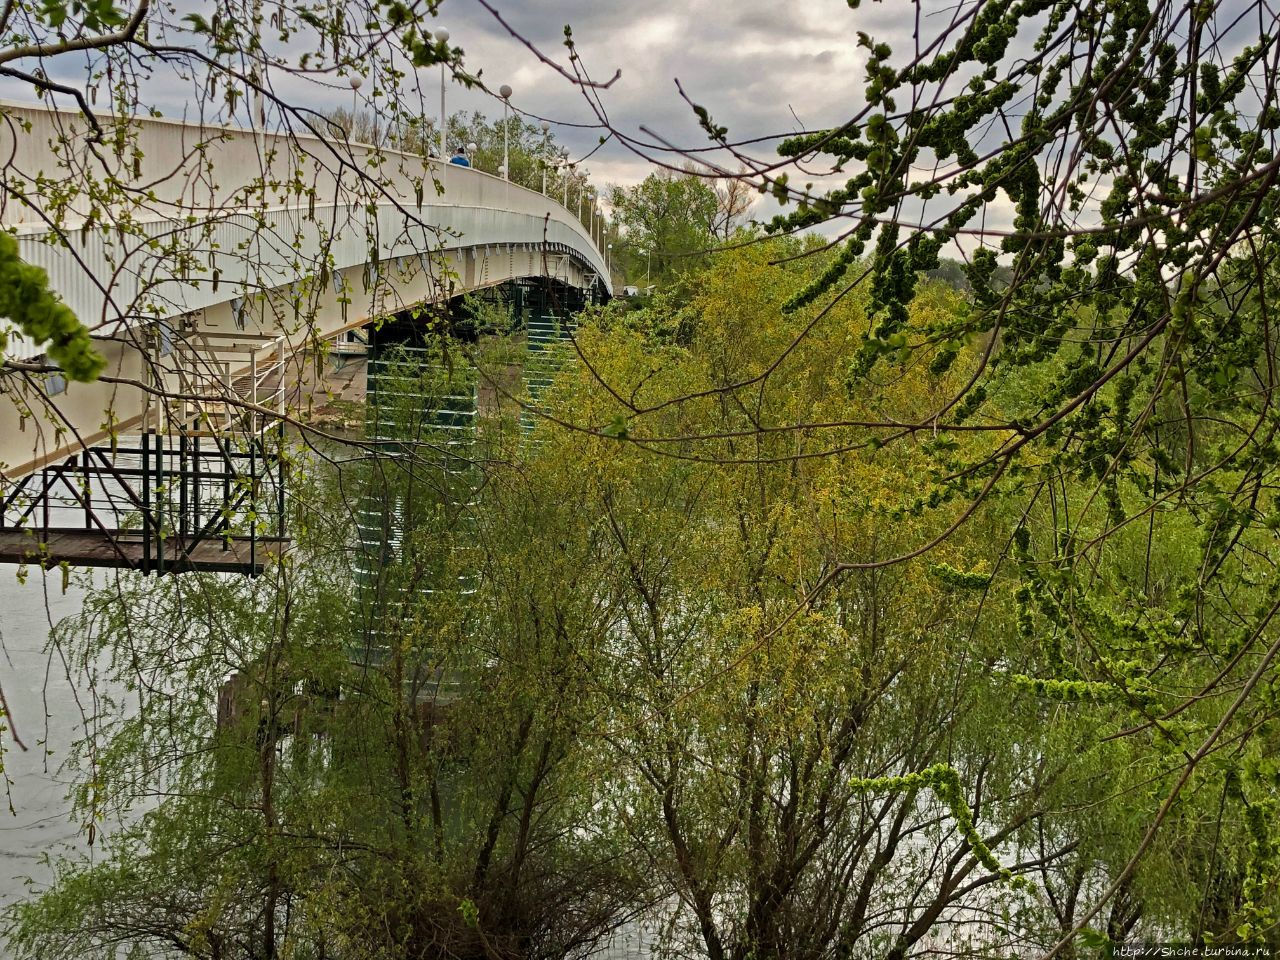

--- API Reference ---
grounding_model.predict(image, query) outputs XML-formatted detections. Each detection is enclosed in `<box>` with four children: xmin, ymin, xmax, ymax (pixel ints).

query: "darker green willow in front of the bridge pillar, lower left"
<box><xmin>3</xmin><ymin>358</ymin><xmax>640</xmax><ymax>960</ymax></box>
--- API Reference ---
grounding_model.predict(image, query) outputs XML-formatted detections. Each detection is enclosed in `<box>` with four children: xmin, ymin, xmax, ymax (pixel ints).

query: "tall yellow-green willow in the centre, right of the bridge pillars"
<box><xmin>494</xmin><ymin>236</ymin><xmax>1075</xmax><ymax>957</ymax></box>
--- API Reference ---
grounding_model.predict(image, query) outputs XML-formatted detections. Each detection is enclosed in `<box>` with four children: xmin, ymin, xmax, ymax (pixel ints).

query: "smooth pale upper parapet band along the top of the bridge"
<box><xmin>0</xmin><ymin>100</ymin><xmax>599</xmax><ymax>244</ymax></box>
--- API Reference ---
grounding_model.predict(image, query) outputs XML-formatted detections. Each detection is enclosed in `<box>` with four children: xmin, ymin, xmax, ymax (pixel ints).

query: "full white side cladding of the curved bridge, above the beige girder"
<box><xmin>0</xmin><ymin>101</ymin><xmax>608</xmax><ymax>358</ymax></box>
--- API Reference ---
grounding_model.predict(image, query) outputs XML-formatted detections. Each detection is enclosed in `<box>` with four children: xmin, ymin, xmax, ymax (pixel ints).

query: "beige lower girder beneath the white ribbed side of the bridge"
<box><xmin>0</xmin><ymin>246</ymin><xmax>596</xmax><ymax>481</ymax></box>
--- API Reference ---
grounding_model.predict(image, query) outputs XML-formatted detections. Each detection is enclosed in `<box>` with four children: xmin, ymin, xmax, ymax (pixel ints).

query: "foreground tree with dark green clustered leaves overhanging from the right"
<box><xmin>509</xmin><ymin>0</ymin><xmax>1280</xmax><ymax>954</ymax></box>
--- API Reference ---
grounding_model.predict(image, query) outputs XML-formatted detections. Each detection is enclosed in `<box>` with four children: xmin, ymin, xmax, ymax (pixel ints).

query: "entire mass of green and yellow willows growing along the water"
<box><xmin>9</xmin><ymin>227</ymin><xmax>1277</xmax><ymax>960</ymax></box>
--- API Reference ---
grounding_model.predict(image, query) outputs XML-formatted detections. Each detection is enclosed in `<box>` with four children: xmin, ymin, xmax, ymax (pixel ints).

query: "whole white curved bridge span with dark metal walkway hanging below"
<box><xmin>0</xmin><ymin>102</ymin><xmax>612</xmax><ymax>572</ymax></box>
